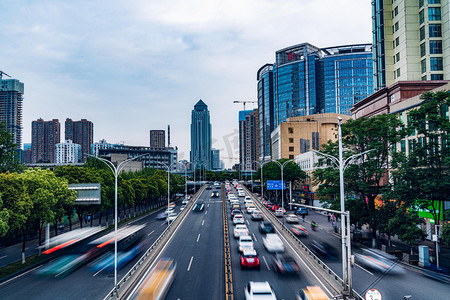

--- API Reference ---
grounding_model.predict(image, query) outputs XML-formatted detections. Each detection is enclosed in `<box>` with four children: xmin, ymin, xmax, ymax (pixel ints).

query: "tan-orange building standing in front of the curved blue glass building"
<box><xmin>271</xmin><ymin>113</ymin><xmax>351</xmax><ymax>160</ymax></box>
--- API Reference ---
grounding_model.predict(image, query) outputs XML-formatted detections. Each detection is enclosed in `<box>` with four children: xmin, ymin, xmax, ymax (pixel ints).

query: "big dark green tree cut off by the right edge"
<box><xmin>390</xmin><ymin>92</ymin><xmax>450</xmax><ymax>224</ymax></box>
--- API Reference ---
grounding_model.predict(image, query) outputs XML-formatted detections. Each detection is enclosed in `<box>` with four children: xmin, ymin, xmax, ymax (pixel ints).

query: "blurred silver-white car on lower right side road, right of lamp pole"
<box><xmin>354</xmin><ymin>249</ymin><xmax>405</xmax><ymax>274</ymax></box>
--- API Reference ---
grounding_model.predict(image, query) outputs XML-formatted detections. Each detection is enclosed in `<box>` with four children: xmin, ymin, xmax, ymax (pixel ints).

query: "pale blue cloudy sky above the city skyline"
<box><xmin>0</xmin><ymin>0</ymin><xmax>372</xmax><ymax>167</ymax></box>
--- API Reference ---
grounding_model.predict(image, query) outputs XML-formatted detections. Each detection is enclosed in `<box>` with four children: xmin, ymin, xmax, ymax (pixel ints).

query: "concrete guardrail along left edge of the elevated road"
<box><xmin>103</xmin><ymin>185</ymin><xmax>205</xmax><ymax>300</ymax></box>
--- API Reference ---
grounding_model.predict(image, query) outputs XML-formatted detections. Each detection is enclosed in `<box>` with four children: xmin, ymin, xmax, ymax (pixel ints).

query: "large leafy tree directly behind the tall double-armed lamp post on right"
<box><xmin>313</xmin><ymin>114</ymin><xmax>405</xmax><ymax>243</ymax></box>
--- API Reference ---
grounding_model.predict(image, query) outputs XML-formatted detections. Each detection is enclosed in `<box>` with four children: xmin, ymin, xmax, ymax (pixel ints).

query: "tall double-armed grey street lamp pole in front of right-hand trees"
<box><xmin>311</xmin><ymin>117</ymin><xmax>375</xmax><ymax>294</ymax></box>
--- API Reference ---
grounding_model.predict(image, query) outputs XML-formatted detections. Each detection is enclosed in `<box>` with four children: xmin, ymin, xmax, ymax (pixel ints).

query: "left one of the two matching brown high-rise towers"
<box><xmin>31</xmin><ymin>119</ymin><xmax>61</xmax><ymax>163</ymax></box>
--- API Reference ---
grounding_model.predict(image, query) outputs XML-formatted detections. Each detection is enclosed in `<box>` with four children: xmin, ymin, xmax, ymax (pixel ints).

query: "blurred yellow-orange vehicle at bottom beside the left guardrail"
<box><xmin>136</xmin><ymin>258</ymin><xmax>177</xmax><ymax>300</ymax></box>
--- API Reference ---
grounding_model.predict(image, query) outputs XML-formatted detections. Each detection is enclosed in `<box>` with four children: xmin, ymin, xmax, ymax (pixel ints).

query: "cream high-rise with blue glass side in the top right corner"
<box><xmin>372</xmin><ymin>0</ymin><xmax>450</xmax><ymax>90</ymax></box>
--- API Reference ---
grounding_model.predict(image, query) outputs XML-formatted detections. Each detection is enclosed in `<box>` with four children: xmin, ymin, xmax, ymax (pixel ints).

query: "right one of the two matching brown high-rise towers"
<box><xmin>65</xmin><ymin>118</ymin><xmax>94</xmax><ymax>162</ymax></box>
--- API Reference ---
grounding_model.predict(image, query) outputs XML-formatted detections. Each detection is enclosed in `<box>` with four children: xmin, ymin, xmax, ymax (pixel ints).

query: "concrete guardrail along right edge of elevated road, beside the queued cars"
<box><xmin>244</xmin><ymin>187</ymin><xmax>364</xmax><ymax>300</ymax></box>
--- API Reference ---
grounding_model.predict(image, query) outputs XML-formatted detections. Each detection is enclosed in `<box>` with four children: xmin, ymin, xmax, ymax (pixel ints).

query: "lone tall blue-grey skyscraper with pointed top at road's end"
<box><xmin>190</xmin><ymin>99</ymin><xmax>212</xmax><ymax>169</ymax></box>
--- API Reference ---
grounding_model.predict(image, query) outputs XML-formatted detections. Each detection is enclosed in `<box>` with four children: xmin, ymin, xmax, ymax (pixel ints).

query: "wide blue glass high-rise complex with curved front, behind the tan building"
<box><xmin>257</xmin><ymin>43</ymin><xmax>374</xmax><ymax>159</ymax></box>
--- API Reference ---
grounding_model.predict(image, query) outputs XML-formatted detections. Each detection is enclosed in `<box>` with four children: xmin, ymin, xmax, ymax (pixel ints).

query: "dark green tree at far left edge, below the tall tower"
<box><xmin>0</xmin><ymin>122</ymin><xmax>25</xmax><ymax>173</ymax></box>
